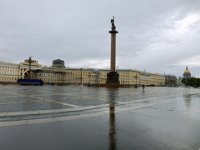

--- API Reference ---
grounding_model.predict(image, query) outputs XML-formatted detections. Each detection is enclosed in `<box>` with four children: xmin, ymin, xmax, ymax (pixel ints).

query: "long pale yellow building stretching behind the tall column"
<box><xmin>0</xmin><ymin>60</ymin><xmax>165</xmax><ymax>86</ymax></box>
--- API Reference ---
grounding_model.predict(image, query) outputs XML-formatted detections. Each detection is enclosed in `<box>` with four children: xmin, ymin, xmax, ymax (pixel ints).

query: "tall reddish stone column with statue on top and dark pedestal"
<box><xmin>106</xmin><ymin>17</ymin><xmax>120</xmax><ymax>87</ymax></box>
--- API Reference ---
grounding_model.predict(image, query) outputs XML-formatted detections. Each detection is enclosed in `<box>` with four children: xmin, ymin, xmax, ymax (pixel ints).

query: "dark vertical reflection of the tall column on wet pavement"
<box><xmin>108</xmin><ymin>89</ymin><xmax>118</xmax><ymax>150</ymax></box>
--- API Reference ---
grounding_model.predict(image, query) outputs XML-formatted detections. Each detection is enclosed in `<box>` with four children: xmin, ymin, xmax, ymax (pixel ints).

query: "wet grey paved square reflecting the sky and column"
<box><xmin>0</xmin><ymin>85</ymin><xmax>200</xmax><ymax>150</ymax></box>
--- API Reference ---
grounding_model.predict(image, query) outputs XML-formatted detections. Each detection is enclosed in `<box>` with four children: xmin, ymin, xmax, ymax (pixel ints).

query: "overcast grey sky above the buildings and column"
<box><xmin>0</xmin><ymin>0</ymin><xmax>200</xmax><ymax>77</ymax></box>
